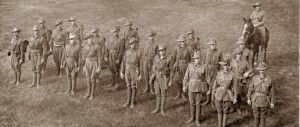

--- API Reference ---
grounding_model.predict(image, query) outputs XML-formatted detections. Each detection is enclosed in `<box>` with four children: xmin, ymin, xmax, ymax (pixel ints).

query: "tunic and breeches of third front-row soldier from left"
<box><xmin>62</xmin><ymin>44</ymin><xmax>81</xmax><ymax>79</ymax></box>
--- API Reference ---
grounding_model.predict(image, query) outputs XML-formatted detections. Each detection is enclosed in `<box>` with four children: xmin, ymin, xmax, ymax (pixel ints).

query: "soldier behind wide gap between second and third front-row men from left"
<box><xmin>50</xmin><ymin>20</ymin><xmax>68</xmax><ymax>77</ymax></box>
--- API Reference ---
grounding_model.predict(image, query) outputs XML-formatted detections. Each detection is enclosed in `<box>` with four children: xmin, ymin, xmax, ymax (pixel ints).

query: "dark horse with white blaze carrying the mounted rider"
<box><xmin>242</xmin><ymin>18</ymin><xmax>269</xmax><ymax>65</ymax></box>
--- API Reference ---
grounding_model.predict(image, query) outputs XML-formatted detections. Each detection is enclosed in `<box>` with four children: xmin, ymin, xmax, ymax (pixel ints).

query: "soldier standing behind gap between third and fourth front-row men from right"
<box><xmin>171</xmin><ymin>35</ymin><xmax>192</xmax><ymax>100</ymax></box>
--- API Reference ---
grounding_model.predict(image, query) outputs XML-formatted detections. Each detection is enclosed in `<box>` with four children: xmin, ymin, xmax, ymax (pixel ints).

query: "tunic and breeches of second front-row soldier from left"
<box><xmin>28</xmin><ymin>36</ymin><xmax>47</xmax><ymax>73</ymax></box>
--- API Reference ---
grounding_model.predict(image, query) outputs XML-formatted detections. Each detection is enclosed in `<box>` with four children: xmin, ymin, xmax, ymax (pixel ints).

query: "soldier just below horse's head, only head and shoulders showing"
<box><xmin>233</xmin><ymin>37</ymin><xmax>251</xmax><ymax>63</ymax></box>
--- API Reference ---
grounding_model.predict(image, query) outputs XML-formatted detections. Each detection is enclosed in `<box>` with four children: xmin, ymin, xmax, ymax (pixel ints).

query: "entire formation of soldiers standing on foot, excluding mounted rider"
<box><xmin>9</xmin><ymin>2</ymin><xmax>274</xmax><ymax>127</ymax></box>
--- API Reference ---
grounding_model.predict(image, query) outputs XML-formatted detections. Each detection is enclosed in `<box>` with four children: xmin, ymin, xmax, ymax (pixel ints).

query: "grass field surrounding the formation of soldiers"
<box><xmin>0</xmin><ymin>0</ymin><xmax>299</xmax><ymax>127</ymax></box>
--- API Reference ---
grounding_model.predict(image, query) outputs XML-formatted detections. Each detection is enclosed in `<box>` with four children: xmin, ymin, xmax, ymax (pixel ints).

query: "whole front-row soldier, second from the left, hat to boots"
<box><xmin>28</xmin><ymin>25</ymin><xmax>47</xmax><ymax>88</ymax></box>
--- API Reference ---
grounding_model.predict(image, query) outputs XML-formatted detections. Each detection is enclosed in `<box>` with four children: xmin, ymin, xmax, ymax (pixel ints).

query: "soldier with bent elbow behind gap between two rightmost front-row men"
<box><xmin>230</xmin><ymin>49</ymin><xmax>253</xmax><ymax>115</ymax></box>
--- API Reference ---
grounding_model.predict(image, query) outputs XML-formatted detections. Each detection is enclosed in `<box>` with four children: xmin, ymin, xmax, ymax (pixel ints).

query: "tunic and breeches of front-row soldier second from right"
<box><xmin>212</xmin><ymin>71</ymin><xmax>237</xmax><ymax>114</ymax></box>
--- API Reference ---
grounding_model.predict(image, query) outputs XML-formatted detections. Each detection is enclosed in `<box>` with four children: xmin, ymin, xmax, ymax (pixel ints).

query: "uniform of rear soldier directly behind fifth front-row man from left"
<box><xmin>124</xmin><ymin>28</ymin><xmax>140</xmax><ymax>50</ymax></box>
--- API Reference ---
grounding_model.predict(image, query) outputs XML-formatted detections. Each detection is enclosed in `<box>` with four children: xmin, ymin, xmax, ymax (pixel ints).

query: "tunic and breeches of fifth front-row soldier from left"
<box><xmin>121</xmin><ymin>49</ymin><xmax>141</xmax><ymax>89</ymax></box>
